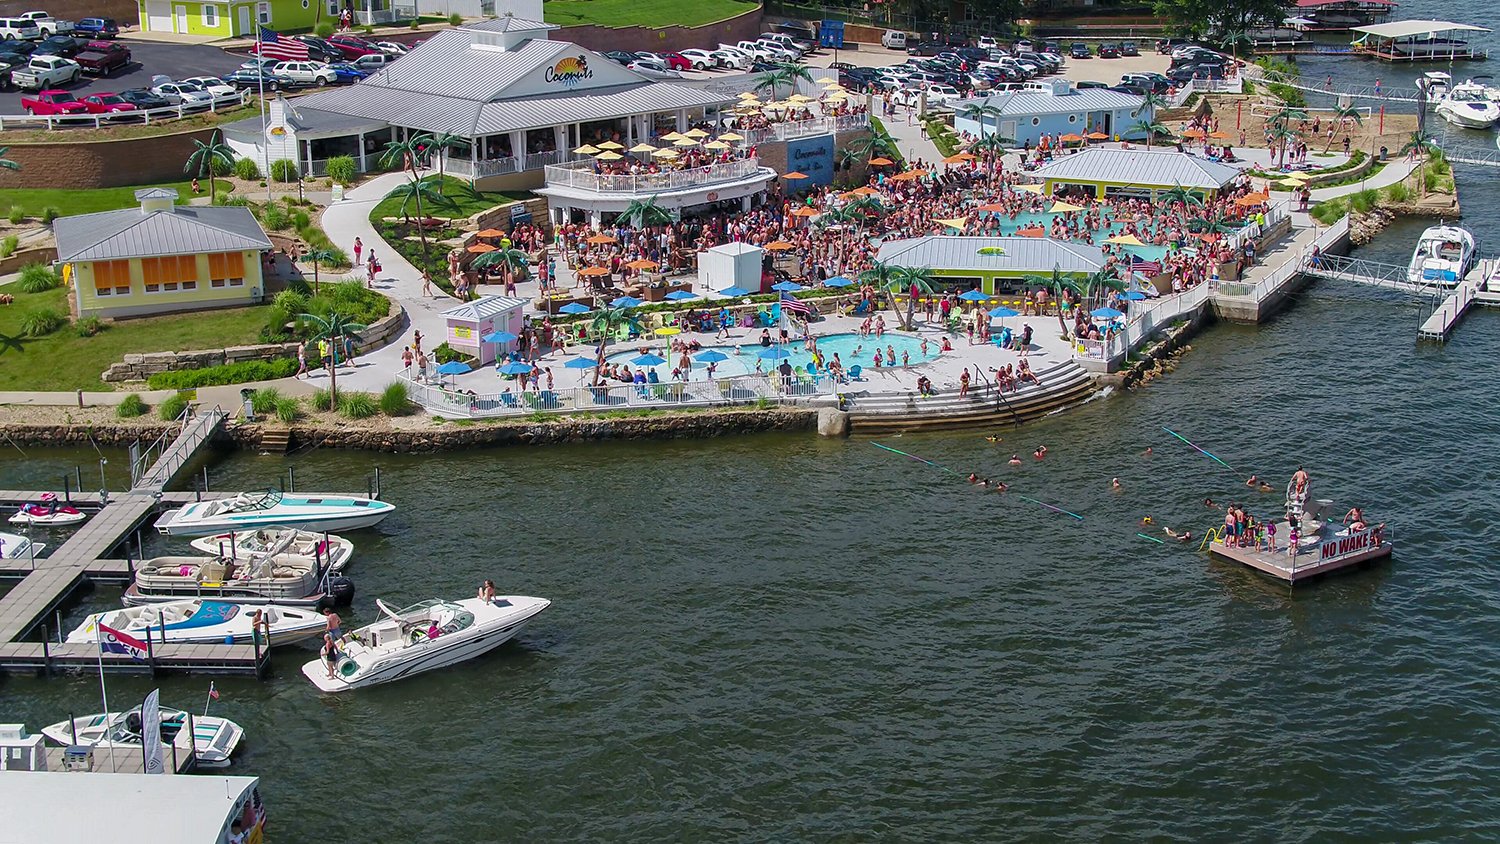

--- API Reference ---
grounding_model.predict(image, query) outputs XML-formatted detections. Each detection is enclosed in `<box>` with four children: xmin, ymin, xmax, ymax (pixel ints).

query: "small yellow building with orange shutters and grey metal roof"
<box><xmin>53</xmin><ymin>187</ymin><xmax>272</xmax><ymax>318</ymax></box>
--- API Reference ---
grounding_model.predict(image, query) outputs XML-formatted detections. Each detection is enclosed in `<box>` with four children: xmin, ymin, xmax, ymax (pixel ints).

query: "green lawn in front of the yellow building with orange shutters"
<box><xmin>0</xmin><ymin>285</ymin><xmax>267</xmax><ymax>390</ymax></box>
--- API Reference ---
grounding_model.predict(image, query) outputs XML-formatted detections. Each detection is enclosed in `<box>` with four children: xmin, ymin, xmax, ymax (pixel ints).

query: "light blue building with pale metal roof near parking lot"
<box><xmin>954</xmin><ymin>79</ymin><xmax>1152</xmax><ymax>147</ymax></box>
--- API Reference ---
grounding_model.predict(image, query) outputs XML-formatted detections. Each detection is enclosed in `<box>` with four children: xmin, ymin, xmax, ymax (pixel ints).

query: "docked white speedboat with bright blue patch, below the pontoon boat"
<box><xmin>68</xmin><ymin>600</ymin><xmax>329</xmax><ymax>646</ymax></box>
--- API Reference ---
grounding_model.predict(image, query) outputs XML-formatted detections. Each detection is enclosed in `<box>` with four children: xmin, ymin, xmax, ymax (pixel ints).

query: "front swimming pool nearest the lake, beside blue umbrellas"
<box><xmin>605</xmin><ymin>331</ymin><xmax>938</xmax><ymax>381</ymax></box>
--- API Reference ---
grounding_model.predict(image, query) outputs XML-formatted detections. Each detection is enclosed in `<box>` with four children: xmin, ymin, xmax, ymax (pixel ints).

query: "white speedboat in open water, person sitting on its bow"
<box><xmin>302</xmin><ymin>595</ymin><xmax>552</xmax><ymax>691</ymax></box>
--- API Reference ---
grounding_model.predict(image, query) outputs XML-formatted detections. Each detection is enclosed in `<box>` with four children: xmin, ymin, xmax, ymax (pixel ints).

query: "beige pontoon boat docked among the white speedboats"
<box><xmin>123</xmin><ymin>553</ymin><xmax>354</xmax><ymax>607</ymax></box>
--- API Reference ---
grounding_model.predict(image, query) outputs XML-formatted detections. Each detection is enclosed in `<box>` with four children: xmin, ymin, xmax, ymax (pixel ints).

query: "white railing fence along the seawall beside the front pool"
<box><xmin>404</xmin><ymin>373</ymin><xmax>836</xmax><ymax>418</ymax></box>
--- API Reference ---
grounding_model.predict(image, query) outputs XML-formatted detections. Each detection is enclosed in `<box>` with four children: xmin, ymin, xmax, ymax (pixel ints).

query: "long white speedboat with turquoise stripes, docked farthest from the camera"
<box><xmin>156</xmin><ymin>489</ymin><xmax>396</xmax><ymax>537</ymax></box>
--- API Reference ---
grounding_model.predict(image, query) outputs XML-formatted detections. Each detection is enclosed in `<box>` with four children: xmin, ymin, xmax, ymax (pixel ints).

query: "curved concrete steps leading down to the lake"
<box><xmin>846</xmin><ymin>360</ymin><xmax>1095</xmax><ymax>433</ymax></box>
